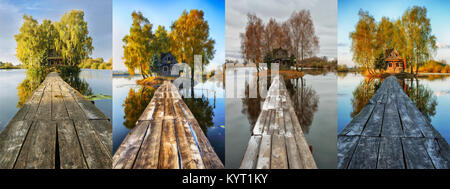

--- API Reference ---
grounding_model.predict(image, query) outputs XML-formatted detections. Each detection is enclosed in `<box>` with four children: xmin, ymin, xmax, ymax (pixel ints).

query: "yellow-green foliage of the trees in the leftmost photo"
<box><xmin>14</xmin><ymin>10</ymin><xmax>93</xmax><ymax>68</ymax></box>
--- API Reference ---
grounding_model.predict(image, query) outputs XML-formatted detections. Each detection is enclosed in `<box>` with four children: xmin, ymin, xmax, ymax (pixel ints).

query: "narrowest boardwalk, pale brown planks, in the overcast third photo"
<box><xmin>240</xmin><ymin>76</ymin><xmax>317</xmax><ymax>169</ymax></box>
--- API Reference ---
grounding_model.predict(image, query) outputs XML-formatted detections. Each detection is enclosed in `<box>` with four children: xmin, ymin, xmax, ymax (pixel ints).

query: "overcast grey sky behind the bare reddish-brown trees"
<box><xmin>225</xmin><ymin>0</ymin><xmax>337</xmax><ymax>59</ymax></box>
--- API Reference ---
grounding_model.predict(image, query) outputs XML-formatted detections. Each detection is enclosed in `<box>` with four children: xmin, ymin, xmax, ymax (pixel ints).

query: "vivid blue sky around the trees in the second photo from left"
<box><xmin>113</xmin><ymin>0</ymin><xmax>225</xmax><ymax>70</ymax></box>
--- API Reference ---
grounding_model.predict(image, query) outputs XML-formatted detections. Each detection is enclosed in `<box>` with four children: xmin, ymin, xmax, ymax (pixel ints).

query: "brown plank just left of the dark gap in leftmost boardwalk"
<box><xmin>14</xmin><ymin>120</ymin><xmax>56</xmax><ymax>169</ymax></box>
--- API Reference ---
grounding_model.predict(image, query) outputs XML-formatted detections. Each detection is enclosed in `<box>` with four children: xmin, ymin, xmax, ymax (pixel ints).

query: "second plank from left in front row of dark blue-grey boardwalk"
<box><xmin>348</xmin><ymin>137</ymin><xmax>380</xmax><ymax>169</ymax></box>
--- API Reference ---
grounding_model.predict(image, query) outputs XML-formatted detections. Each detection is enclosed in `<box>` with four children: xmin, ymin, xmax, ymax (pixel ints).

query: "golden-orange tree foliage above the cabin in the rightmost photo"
<box><xmin>350</xmin><ymin>6</ymin><xmax>437</xmax><ymax>75</ymax></box>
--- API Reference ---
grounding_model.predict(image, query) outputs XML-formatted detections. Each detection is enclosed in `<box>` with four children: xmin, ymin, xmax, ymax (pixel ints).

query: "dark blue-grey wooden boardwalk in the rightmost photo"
<box><xmin>338</xmin><ymin>76</ymin><xmax>450</xmax><ymax>169</ymax></box>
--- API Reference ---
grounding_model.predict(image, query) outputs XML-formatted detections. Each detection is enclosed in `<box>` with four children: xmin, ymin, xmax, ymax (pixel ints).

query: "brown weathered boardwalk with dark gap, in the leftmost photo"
<box><xmin>0</xmin><ymin>72</ymin><xmax>112</xmax><ymax>169</ymax></box>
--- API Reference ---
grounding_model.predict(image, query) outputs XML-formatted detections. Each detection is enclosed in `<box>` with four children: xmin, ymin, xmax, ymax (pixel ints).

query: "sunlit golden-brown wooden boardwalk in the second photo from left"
<box><xmin>113</xmin><ymin>81</ymin><xmax>224</xmax><ymax>169</ymax></box>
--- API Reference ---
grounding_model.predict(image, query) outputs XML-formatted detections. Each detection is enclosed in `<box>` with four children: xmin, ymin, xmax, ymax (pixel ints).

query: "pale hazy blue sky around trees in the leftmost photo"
<box><xmin>0</xmin><ymin>0</ymin><xmax>112</xmax><ymax>64</ymax></box>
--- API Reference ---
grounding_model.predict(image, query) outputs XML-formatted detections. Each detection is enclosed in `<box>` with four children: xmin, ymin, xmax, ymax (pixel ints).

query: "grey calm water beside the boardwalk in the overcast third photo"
<box><xmin>225</xmin><ymin>70</ymin><xmax>337</xmax><ymax>168</ymax></box>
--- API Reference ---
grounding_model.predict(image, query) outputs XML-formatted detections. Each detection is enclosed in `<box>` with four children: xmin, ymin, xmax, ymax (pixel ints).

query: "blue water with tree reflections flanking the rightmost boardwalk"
<box><xmin>338</xmin><ymin>73</ymin><xmax>450</xmax><ymax>142</ymax></box>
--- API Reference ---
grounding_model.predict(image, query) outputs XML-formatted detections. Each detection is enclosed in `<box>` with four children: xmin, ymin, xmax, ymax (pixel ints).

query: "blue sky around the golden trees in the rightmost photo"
<box><xmin>338</xmin><ymin>0</ymin><xmax>450</xmax><ymax>66</ymax></box>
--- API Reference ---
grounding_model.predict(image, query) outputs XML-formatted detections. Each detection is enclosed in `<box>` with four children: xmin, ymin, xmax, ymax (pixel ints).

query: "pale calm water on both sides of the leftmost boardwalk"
<box><xmin>0</xmin><ymin>69</ymin><xmax>112</xmax><ymax>130</ymax></box>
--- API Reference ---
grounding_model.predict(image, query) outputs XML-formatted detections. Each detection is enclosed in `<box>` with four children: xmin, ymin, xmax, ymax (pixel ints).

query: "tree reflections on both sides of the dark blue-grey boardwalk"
<box><xmin>351</xmin><ymin>79</ymin><xmax>437</xmax><ymax>121</ymax></box>
